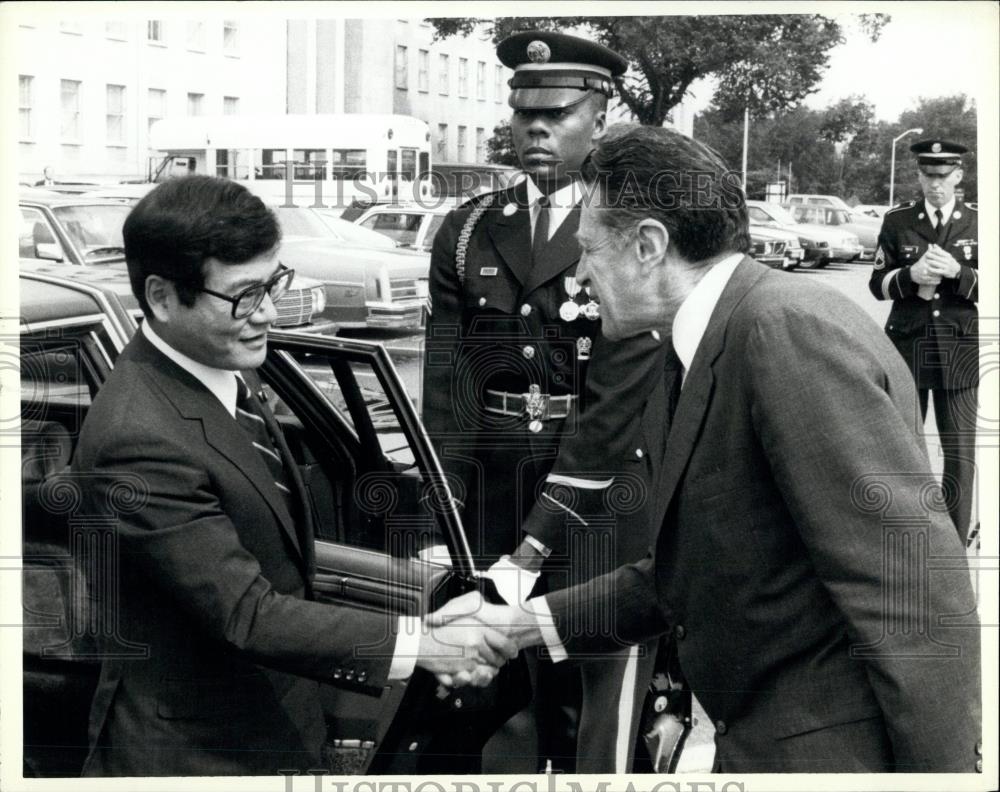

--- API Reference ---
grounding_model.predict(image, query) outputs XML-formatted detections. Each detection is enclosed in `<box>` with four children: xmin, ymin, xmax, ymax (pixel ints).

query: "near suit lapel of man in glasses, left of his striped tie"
<box><xmin>135</xmin><ymin>333</ymin><xmax>306</xmax><ymax>560</ymax></box>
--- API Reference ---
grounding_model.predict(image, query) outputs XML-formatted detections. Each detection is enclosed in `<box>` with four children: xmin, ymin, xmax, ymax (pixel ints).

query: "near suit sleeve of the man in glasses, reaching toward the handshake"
<box><xmin>83</xmin><ymin>423</ymin><xmax>397</xmax><ymax>692</ymax></box>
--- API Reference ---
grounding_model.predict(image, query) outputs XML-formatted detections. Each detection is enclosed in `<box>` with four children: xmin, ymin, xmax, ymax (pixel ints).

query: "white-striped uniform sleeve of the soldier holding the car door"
<box><xmin>523</xmin><ymin>333</ymin><xmax>667</xmax><ymax>568</ymax></box>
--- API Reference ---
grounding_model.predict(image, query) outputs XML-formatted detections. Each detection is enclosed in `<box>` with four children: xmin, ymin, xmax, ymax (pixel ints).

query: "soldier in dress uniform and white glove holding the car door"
<box><xmin>423</xmin><ymin>32</ymin><xmax>666</xmax><ymax>772</ymax></box>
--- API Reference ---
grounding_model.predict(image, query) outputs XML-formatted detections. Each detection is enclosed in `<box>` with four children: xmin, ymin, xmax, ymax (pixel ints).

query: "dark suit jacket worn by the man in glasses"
<box><xmin>74</xmin><ymin>333</ymin><xmax>391</xmax><ymax>776</ymax></box>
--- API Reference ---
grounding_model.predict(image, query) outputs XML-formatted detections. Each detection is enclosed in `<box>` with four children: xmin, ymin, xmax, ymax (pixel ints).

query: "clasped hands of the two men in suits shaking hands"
<box><xmin>417</xmin><ymin>591</ymin><xmax>518</xmax><ymax>687</ymax></box>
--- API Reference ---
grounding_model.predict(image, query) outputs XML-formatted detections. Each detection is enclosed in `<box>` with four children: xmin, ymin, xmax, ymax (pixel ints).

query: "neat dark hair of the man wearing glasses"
<box><xmin>122</xmin><ymin>176</ymin><xmax>281</xmax><ymax>316</ymax></box>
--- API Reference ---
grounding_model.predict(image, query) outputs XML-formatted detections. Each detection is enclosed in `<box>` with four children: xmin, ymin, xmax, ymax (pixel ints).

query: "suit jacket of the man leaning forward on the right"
<box><xmin>548</xmin><ymin>259</ymin><xmax>981</xmax><ymax>772</ymax></box>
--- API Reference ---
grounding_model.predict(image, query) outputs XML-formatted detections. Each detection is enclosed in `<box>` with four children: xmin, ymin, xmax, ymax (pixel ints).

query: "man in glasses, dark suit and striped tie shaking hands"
<box><xmin>74</xmin><ymin>176</ymin><xmax>512</xmax><ymax>776</ymax></box>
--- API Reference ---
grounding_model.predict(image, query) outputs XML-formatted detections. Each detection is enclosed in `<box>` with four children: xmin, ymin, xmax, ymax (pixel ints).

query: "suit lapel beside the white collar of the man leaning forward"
<box><xmin>659</xmin><ymin>258</ymin><xmax>767</xmax><ymax>521</ymax></box>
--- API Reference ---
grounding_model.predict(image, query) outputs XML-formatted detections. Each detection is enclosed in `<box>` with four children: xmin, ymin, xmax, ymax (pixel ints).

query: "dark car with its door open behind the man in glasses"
<box><xmin>21</xmin><ymin>267</ymin><xmax>513</xmax><ymax>777</ymax></box>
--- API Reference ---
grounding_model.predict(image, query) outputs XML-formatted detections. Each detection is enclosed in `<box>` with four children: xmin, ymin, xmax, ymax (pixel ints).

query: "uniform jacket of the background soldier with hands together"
<box><xmin>869</xmin><ymin>200</ymin><xmax>979</xmax><ymax>389</ymax></box>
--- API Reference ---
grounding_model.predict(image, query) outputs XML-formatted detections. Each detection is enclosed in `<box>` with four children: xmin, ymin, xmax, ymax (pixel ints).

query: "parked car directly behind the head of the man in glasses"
<box><xmin>18</xmin><ymin>190</ymin><xmax>337</xmax><ymax>334</ymax></box>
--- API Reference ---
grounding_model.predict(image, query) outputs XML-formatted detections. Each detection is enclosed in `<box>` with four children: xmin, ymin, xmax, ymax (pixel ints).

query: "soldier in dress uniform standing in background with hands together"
<box><xmin>869</xmin><ymin>139</ymin><xmax>979</xmax><ymax>541</ymax></box>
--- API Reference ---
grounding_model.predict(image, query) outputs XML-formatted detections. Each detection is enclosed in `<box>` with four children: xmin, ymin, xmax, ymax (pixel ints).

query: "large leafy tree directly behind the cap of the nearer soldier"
<box><xmin>427</xmin><ymin>14</ymin><xmax>889</xmax><ymax>126</ymax></box>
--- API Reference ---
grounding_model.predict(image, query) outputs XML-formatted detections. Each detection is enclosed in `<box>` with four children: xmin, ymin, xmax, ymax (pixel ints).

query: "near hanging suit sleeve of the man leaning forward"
<box><xmin>746</xmin><ymin>302</ymin><xmax>981</xmax><ymax>772</ymax></box>
